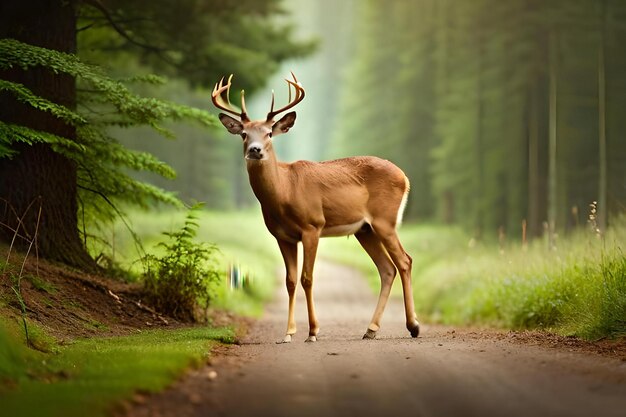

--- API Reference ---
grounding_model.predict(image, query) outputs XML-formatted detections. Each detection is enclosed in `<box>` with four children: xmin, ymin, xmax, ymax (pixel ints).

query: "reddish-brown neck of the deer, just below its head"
<box><xmin>246</xmin><ymin>155</ymin><xmax>285</xmax><ymax>209</ymax></box>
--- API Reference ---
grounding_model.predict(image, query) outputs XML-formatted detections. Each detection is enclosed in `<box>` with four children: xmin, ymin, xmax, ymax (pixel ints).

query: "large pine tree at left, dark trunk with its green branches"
<box><xmin>0</xmin><ymin>0</ymin><xmax>312</xmax><ymax>270</ymax></box>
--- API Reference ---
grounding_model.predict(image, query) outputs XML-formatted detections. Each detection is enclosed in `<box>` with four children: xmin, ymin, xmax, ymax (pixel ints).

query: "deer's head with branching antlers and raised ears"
<box><xmin>211</xmin><ymin>72</ymin><xmax>304</xmax><ymax>161</ymax></box>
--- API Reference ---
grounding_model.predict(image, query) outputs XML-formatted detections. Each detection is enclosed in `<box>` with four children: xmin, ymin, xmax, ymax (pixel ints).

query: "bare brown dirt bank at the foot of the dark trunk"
<box><xmin>0</xmin><ymin>248</ymin><xmax>185</xmax><ymax>342</ymax></box>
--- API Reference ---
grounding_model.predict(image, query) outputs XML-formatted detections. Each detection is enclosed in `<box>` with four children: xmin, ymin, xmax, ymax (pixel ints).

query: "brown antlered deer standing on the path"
<box><xmin>211</xmin><ymin>72</ymin><xmax>419</xmax><ymax>343</ymax></box>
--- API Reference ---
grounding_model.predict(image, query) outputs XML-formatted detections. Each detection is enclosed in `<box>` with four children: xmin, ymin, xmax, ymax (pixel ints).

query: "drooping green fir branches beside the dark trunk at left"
<box><xmin>0</xmin><ymin>39</ymin><xmax>215</xmax><ymax>232</ymax></box>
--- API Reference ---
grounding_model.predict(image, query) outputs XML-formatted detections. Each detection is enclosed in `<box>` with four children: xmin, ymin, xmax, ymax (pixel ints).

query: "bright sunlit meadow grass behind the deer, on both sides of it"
<box><xmin>108</xmin><ymin>210</ymin><xmax>626</xmax><ymax>339</ymax></box>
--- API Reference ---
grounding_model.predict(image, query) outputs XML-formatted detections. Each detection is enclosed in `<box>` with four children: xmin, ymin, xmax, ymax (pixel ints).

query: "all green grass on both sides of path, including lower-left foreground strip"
<box><xmin>0</xmin><ymin>206</ymin><xmax>626</xmax><ymax>417</ymax></box>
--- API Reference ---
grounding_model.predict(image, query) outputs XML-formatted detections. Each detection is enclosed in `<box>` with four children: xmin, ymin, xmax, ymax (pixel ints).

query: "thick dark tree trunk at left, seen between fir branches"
<box><xmin>0</xmin><ymin>0</ymin><xmax>96</xmax><ymax>270</ymax></box>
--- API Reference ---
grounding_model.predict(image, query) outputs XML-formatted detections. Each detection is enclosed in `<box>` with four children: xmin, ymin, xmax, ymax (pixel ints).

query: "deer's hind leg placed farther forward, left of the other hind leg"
<box><xmin>354</xmin><ymin>227</ymin><xmax>396</xmax><ymax>339</ymax></box>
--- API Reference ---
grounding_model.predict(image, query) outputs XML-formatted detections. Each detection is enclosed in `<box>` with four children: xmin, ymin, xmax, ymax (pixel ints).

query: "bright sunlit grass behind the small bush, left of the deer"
<box><xmin>101</xmin><ymin>210</ymin><xmax>282</xmax><ymax>316</ymax></box>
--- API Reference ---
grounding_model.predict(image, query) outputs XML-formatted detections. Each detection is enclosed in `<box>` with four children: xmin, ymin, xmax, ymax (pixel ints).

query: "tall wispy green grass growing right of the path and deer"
<box><xmin>428</xmin><ymin>231</ymin><xmax>626</xmax><ymax>340</ymax></box>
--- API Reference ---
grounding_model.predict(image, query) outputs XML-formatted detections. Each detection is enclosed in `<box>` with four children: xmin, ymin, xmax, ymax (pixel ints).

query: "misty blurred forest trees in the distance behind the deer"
<box><xmin>86</xmin><ymin>0</ymin><xmax>626</xmax><ymax>238</ymax></box>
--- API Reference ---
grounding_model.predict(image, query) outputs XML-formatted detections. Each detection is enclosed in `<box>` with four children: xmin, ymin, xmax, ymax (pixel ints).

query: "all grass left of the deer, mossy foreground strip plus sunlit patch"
<box><xmin>0</xmin><ymin>211</ymin><xmax>266</xmax><ymax>417</ymax></box>
